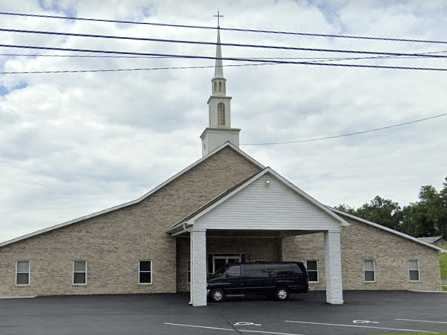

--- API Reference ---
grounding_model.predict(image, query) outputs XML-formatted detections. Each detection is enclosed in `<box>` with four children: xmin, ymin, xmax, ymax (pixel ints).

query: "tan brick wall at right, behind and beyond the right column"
<box><xmin>282</xmin><ymin>220</ymin><xmax>441</xmax><ymax>290</ymax></box>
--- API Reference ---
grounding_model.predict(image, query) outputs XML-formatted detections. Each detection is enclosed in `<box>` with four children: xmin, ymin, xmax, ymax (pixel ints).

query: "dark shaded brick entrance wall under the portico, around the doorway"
<box><xmin>177</xmin><ymin>236</ymin><xmax>281</xmax><ymax>292</ymax></box>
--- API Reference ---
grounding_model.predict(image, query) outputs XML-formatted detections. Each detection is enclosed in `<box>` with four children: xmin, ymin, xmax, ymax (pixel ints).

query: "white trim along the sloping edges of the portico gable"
<box><xmin>169</xmin><ymin>167</ymin><xmax>349</xmax><ymax>235</ymax></box>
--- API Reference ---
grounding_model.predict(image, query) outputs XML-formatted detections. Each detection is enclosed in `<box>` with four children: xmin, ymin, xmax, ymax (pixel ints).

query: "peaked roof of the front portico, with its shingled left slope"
<box><xmin>168</xmin><ymin>167</ymin><xmax>349</xmax><ymax>235</ymax></box>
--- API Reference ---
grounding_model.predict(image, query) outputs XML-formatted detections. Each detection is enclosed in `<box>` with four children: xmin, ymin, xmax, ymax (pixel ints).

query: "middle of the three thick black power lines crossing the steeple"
<box><xmin>0</xmin><ymin>28</ymin><xmax>447</xmax><ymax>58</ymax></box>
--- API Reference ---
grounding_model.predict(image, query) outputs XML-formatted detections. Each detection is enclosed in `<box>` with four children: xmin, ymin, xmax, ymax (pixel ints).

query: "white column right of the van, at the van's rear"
<box><xmin>324</xmin><ymin>231</ymin><xmax>343</xmax><ymax>304</ymax></box>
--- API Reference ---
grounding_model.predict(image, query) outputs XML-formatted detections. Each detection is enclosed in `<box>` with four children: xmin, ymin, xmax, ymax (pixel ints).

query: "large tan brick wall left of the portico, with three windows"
<box><xmin>0</xmin><ymin>148</ymin><xmax>259</xmax><ymax>296</ymax></box>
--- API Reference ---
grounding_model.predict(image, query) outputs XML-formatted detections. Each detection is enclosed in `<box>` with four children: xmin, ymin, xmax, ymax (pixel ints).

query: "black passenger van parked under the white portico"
<box><xmin>208</xmin><ymin>262</ymin><xmax>309</xmax><ymax>302</ymax></box>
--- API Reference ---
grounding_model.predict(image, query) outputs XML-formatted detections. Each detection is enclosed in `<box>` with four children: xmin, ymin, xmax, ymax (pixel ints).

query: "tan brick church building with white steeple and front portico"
<box><xmin>0</xmin><ymin>30</ymin><xmax>442</xmax><ymax>306</ymax></box>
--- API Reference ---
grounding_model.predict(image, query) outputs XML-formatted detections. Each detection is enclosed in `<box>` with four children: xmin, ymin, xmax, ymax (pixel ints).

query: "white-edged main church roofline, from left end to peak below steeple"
<box><xmin>0</xmin><ymin>142</ymin><xmax>264</xmax><ymax>248</ymax></box>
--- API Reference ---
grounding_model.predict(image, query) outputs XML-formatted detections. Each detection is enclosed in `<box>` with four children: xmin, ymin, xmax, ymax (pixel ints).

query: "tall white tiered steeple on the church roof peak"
<box><xmin>200</xmin><ymin>19</ymin><xmax>240</xmax><ymax>156</ymax></box>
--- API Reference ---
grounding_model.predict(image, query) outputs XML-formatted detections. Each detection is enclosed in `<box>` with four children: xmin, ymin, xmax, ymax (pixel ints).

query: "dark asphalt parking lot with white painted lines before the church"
<box><xmin>0</xmin><ymin>292</ymin><xmax>447</xmax><ymax>335</ymax></box>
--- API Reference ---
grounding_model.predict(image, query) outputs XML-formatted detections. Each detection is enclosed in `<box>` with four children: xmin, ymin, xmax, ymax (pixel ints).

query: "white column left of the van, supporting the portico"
<box><xmin>190</xmin><ymin>230</ymin><xmax>207</xmax><ymax>307</ymax></box>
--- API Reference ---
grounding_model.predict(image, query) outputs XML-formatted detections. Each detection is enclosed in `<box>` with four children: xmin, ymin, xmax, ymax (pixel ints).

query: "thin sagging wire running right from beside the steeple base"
<box><xmin>241</xmin><ymin>113</ymin><xmax>447</xmax><ymax>146</ymax></box>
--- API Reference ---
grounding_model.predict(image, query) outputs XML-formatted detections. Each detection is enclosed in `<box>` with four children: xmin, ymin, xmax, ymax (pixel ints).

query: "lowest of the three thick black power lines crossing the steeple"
<box><xmin>0</xmin><ymin>44</ymin><xmax>447</xmax><ymax>72</ymax></box>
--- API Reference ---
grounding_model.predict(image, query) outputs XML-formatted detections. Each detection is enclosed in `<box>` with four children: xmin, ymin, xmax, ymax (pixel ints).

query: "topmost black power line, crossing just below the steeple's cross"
<box><xmin>0</xmin><ymin>12</ymin><xmax>447</xmax><ymax>44</ymax></box>
